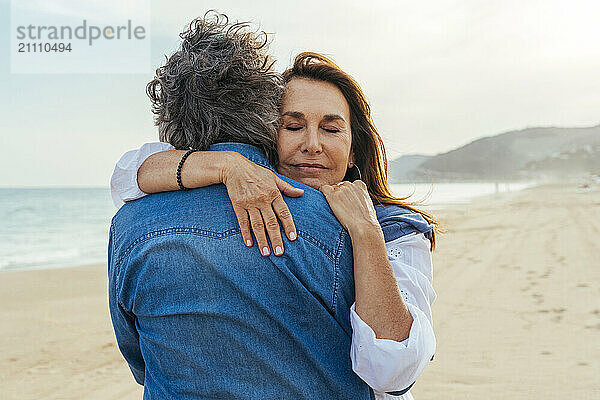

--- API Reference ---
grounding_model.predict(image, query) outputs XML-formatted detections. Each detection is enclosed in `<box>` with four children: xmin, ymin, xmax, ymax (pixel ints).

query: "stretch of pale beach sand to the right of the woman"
<box><xmin>412</xmin><ymin>185</ymin><xmax>600</xmax><ymax>399</ymax></box>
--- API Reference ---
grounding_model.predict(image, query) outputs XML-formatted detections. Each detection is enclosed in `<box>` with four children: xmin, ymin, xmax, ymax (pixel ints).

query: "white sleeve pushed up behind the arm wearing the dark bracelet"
<box><xmin>110</xmin><ymin>142</ymin><xmax>175</xmax><ymax>208</ymax></box>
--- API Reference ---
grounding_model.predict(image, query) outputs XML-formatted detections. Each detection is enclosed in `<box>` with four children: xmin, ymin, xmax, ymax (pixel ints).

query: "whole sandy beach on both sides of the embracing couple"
<box><xmin>0</xmin><ymin>184</ymin><xmax>600</xmax><ymax>400</ymax></box>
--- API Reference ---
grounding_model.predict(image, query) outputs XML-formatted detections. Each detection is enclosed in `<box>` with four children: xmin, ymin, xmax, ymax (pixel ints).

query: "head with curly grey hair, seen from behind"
<box><xmin>146</xmin><ymin>12</ymin><xmax>284</xmax><ymax>164</ymax></box>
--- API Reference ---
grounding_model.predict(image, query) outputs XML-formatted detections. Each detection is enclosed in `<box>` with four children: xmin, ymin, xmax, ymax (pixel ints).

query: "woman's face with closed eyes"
<box><xmin>277</xmin><ymin>78</ymin><xmax>353</xmax><ymax>189</ymax></box>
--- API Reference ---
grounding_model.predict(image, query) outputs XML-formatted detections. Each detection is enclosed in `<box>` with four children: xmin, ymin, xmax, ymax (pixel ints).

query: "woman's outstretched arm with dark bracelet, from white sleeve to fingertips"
<box><xmin>111</xmin><ymin>143</ymin><xmax>304</xmax><ymax>256</ymax></box>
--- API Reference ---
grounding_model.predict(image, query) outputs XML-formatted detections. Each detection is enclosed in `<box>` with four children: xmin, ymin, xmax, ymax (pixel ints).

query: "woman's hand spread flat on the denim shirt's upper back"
<box><xmin>221</xmin><ymin>156</ymin><xmax>304</xmax><ymax>256</ymax></box>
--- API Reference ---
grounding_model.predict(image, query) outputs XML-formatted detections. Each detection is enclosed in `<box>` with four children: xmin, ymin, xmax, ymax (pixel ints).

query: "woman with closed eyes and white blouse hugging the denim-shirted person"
<box><xmin>111</xmin><ymin>53</ymin><xmax>437</xmax><ymax>399</ymax></box>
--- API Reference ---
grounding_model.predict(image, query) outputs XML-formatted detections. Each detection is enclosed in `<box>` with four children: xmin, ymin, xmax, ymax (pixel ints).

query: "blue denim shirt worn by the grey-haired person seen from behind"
<box><xmin>108</xmin><ymin>143</ymin><xmax>374</xmax><ymax>399</ymax></box>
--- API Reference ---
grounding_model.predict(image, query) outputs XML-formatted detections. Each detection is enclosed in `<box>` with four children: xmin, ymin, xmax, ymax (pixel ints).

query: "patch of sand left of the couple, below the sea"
<box><xmin>0</xmin><ymin>265</ymin><xmax>142</xmax><ymax>400</ymax></box>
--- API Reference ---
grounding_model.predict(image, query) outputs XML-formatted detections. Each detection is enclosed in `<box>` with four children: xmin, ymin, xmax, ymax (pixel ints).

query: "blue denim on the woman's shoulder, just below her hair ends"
<box><xmin>375</xmin><ymin>204</ymin><xmax>434</xmax><ymax>242</ymax></box>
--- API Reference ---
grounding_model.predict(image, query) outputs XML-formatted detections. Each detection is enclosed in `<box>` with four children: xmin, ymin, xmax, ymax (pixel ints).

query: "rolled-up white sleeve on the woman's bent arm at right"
<box><xmin>350</xmin><ymin>232</ymin><xmax>437</xmax><ymax>395</ymax></box>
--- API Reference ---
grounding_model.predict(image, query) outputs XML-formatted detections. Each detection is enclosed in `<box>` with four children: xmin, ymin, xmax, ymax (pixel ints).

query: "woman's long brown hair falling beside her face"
<box><xmin>283</xmin><ymin>52</ymin><xmax>440</xmax><ymax>250</ymax></box>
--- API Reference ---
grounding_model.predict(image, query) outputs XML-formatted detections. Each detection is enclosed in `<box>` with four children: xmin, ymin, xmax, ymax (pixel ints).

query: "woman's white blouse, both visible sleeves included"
<box><xmin>110</xmin><ymin>142</ymin><xmax>437</xmax><ymax>400</ymax></box>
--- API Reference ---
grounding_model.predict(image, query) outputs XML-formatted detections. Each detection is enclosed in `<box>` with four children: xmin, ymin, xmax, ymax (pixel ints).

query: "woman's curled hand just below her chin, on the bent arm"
<box><xmin>320</xmin><ymin>180</ymin><xmax>381</xmax><ymax>236</ymax></box>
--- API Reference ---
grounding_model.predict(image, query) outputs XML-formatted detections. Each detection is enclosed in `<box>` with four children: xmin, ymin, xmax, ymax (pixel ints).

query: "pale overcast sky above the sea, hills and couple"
<box><xmin>0</xmin><ymin>0</ymin><xmax>600</xmax><ymax>186</ymax></box>
